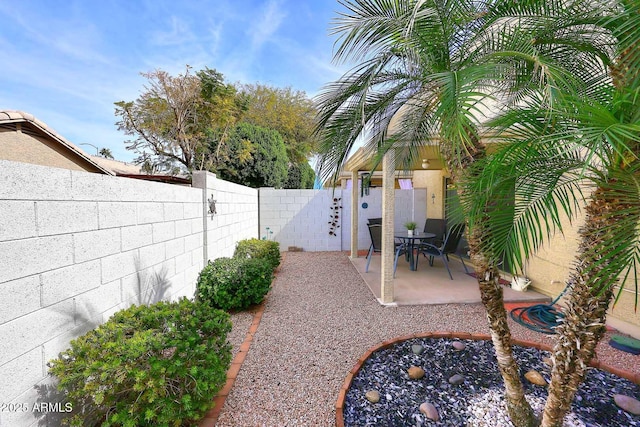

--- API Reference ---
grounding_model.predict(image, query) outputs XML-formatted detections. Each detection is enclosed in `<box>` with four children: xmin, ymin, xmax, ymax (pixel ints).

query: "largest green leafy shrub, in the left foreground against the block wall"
<box><xmin>50</xmin><ymin>298</ymin><xmax>231</xmax><ymax>426</ymax></box>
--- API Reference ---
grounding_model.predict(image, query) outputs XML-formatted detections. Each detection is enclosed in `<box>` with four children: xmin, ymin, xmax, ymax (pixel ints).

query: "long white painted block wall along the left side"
<box><xmin>0</xmin><ymin>160</ymin><xmax>258</xmax><ymax>426</ymax></box>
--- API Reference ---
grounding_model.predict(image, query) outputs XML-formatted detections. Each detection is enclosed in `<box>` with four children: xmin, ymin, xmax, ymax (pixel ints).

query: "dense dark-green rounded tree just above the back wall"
<box><xmin>218</xmin><ymin>123</ymin><xmax>288</xmax><ymax>188</ymax></box>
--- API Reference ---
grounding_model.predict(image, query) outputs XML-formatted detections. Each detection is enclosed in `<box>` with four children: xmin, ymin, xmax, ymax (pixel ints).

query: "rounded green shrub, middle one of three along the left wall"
<box><xmin>196</xmin><ymin>258</ymin><xmax>273</xmax><ymax>310</ymax></box>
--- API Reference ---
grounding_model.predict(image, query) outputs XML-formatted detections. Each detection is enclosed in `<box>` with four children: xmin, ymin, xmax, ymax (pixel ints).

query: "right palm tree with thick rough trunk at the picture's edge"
<box><xmin>466</xmin><ymin>1</ymin><xmax>640</xmax><ymax>427</ymax></box>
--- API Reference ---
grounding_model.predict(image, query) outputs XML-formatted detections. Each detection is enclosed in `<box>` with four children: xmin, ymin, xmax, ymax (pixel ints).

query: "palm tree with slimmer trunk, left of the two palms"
<box><xmin>318</xmin><ymin>0</ymin><xmax>612</xmax><ymax>426</ymax></box>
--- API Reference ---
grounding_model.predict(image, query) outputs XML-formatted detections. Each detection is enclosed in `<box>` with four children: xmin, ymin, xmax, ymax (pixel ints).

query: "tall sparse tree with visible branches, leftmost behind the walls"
<box><xmin>115</xmin><ymin>66</ymin><xmax>246</xmax><ymax>171</ymax></box>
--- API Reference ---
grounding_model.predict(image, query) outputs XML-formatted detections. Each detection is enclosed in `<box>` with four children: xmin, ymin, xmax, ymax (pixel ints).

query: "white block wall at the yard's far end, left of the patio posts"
<box><xmin>260</xmin><ymin>188</ymin><xmax>345</xmax><ymax>252</ymax></box>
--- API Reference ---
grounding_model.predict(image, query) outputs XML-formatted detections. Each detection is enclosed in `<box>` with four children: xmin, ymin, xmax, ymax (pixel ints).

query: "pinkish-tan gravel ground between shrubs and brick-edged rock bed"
<box><xmin>217</xmin><ymin>252</ymin><xmax>640</xmax><ymax>427</ymax></box>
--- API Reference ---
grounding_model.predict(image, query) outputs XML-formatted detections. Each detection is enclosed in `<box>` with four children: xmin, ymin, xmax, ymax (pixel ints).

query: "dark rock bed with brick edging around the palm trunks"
<box><xmin>344</xmin><ymin>338</ymin><xmax>640</xmax><ymax>427</ymax></box>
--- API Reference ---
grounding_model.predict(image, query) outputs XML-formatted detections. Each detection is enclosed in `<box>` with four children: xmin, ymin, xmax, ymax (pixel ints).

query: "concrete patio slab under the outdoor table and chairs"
<box><xmin>351</xmin><ymin>254</ymin><xmax>551</xmax><ymax>305</ymax></box>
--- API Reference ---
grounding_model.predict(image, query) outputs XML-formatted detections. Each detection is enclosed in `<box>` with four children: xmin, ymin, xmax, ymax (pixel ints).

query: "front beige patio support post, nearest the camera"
<box><xmin>380</xmin><ymin>150</ymin><xmax>395</xmax><ymax>304</ymax></box>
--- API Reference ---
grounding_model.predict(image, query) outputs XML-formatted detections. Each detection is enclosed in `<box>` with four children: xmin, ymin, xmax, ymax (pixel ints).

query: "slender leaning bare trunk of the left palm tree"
<box><xmin>468</xmin><ymin>226</ymin><xmax>539</xmax><ymax>427</ymax></box>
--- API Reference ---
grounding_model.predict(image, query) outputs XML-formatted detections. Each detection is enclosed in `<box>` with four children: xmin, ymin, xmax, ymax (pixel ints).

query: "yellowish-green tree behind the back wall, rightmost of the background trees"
<box><xmin>242</xmin><ymin>84</ymin><xmax>317</xmax><ymax>163</ymax></box>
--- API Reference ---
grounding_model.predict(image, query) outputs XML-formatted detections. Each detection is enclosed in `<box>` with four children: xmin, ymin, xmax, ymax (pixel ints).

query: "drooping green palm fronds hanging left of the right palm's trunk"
<box><xmin>462</xmin><ymin>139</ymin><xmax>586</xmax><ymax>269</ymax></box>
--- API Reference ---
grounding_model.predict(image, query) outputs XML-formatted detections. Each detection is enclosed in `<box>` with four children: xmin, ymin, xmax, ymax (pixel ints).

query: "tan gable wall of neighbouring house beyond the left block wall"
<box><xmin>0</xmin><ymin>129</ymin><xmax>102</xmax><ymax>173</ymax></box>
